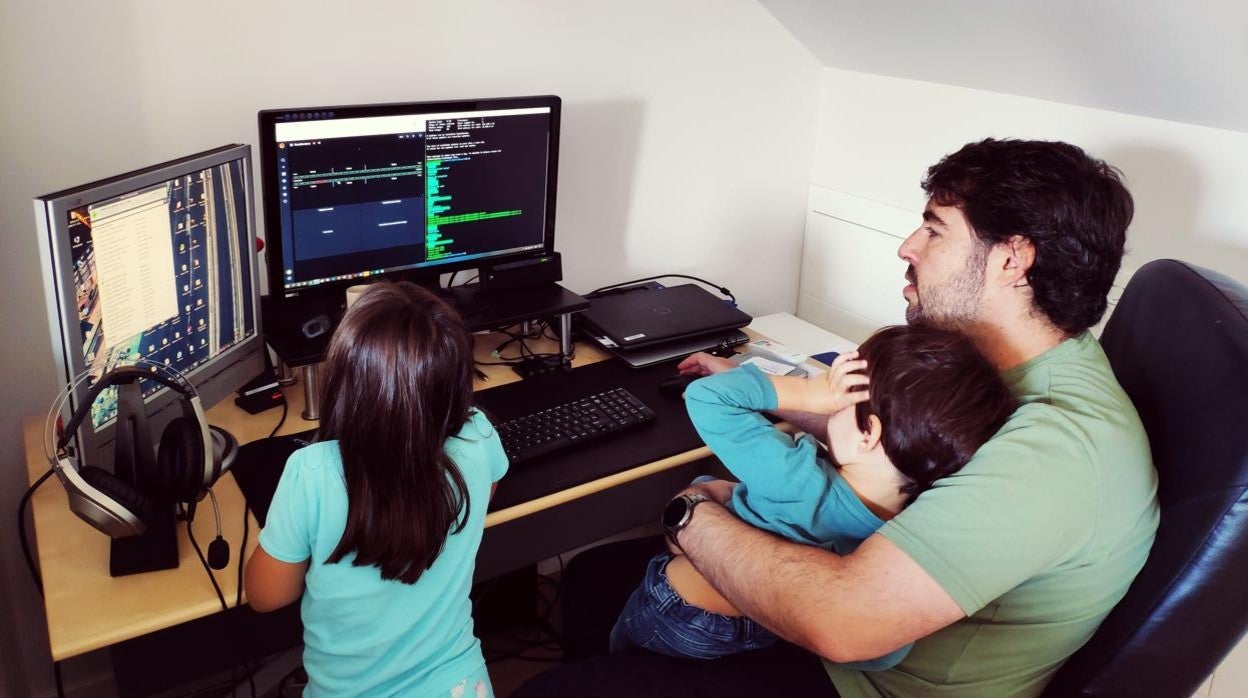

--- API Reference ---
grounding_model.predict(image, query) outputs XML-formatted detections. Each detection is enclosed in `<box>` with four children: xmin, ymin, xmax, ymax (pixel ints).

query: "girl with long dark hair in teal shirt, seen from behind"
<box><xmin>246</xmin><ymin>282</ymin><xmax>507</xmax><ymax>698</ymax></box>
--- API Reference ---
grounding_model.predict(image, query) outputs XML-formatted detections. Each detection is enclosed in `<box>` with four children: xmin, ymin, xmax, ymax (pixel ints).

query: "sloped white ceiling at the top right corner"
<box><xmin>760</xmin><ymin>0</ymin><xmax>1248</xmax><ymax>132</ymax></box>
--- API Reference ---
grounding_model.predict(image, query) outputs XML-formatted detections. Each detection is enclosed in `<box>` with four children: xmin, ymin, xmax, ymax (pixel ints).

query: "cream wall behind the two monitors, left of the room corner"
<box><xmin>0</xmin><ymin>0</ymin><xmax>821</xmax><ymax>694</ymax></box>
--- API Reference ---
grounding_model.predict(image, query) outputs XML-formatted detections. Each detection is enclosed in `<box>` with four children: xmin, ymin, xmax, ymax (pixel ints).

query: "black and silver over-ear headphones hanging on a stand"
<box><xmin>49</xmin><ymin>362</ymin><xmax>238</xmax><ymax>551</ymax></box>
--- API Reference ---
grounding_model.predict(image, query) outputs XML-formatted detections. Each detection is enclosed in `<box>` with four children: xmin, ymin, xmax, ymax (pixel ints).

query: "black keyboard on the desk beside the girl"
<box><xmin>494</xmin><ymin>388</ymin><xmax>654</xmax><ymax>463</ymax></box>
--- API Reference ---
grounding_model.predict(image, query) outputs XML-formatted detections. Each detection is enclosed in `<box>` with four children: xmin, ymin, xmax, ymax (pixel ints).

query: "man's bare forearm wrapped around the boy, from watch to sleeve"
<box><xmin>678</xmin><ymin>487</ymin><xmax>965</xmax><ymax>662</ymax></box>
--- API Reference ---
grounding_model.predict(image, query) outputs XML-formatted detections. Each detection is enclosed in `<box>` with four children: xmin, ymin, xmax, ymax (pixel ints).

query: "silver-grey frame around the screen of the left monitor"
<box><xmin>34</xmin><ymin>144</ymin><xmax>265</xmax><ymax>467</ymax></box>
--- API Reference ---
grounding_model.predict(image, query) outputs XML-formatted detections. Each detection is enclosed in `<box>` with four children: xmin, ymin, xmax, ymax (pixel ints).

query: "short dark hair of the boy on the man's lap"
<box><xmin>856</xmin><ymin>325</ymin><xmax>1017</xmax><ymax>501</ymax></box>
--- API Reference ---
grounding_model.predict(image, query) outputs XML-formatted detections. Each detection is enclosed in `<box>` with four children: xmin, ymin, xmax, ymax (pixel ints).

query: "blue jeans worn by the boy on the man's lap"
<box><xmin>610</xmin><ymin>553</ymin><xmax>779</xmax><ymax>659</ymax></box>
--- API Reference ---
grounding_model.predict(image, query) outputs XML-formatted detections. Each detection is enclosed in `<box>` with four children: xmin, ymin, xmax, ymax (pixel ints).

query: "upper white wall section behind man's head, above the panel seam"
<box><xmin>811</xmin><ymin>69</ymin><xmax>1248</xmax><ymax>290</ymax></box>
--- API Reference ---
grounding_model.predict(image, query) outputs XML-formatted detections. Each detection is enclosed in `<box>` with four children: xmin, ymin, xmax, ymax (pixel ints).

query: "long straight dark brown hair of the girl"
<box><xmin>318</xmin><ymin>282</ymin><xmax>472</xmax><ymax>584</ymax></box>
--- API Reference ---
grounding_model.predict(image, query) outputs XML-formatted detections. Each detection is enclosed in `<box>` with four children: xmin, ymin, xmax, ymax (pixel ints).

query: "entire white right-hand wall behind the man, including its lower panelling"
<box><xmin>800</xmin><ymin>69</ymin><xmax>1248</xmax><ymax>697</ymax></box>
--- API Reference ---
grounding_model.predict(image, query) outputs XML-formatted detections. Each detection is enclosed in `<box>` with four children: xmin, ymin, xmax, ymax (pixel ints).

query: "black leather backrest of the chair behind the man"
<box><xmin>1046</xmin><ymin>260</ymin><xmax>1248</xmax><ymax>697</ymax></box>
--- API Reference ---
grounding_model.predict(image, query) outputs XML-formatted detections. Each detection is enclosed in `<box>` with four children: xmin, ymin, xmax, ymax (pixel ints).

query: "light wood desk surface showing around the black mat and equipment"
<box><xmin>24</xmin><ymin>315</ymin><xmax>844</xmax><ymax>661</ymax></box>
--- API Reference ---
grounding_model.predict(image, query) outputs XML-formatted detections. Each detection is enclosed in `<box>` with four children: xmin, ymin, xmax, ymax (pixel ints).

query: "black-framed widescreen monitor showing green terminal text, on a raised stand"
<box><xmin>260</xmin><ymin>96</ymin><xmax>560</xmax><ymax>298</ymax></box>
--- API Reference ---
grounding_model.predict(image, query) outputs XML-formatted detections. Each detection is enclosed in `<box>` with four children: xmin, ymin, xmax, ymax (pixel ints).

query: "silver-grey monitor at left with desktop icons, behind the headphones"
<box><xmin>35</xmin><ymin>145</ymin><xmax>265</xmax><ymax>467</ymax></box>
